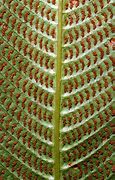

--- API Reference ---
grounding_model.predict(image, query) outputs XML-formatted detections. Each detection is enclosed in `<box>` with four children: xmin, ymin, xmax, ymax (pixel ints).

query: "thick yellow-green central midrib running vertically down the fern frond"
<box><xmin>53</xmin><ymin>0</ymin><xmax>63</xmax><ymax>180</ymax></box>
